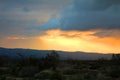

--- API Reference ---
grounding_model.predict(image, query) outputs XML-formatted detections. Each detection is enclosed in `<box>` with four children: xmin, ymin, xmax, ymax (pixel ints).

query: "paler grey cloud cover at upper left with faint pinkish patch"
<box><xmin>0</xmin><ymin>0</ymin><xmax>71</xmax><ymax>36</ymax></box>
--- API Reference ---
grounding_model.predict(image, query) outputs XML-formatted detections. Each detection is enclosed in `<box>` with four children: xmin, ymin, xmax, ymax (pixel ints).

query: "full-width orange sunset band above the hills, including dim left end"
<box><xmin>0</xmin><ymin>29</ymin><xmax>120</xmax><ymax>53</ymax></box>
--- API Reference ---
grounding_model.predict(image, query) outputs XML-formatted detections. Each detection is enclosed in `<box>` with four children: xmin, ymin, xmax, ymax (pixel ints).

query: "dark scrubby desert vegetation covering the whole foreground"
<box><xmin>0</xmin><ymin>51</ymin><xmax>120</xmax><ymax>80</ymax></box>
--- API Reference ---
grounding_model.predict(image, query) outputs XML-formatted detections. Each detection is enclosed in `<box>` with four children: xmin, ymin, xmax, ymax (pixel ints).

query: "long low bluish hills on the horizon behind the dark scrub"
<box><xmin>0</xmin><ymin>48</ymin><xmax>112</xmax><ymax>60</ymax></box>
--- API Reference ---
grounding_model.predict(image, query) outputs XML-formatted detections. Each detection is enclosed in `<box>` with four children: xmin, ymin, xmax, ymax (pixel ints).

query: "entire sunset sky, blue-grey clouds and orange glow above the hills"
<box><xmin>0</xmin><ymin>0</ymin><xmax>120</xmax><ymax>53</ymax></box>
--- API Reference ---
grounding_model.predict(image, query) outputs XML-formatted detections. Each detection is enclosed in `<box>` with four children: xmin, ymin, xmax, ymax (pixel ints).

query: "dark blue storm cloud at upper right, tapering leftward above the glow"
<box><xmin>32</xmin><ymin>0</ymin><xmax>120</xmax><ymax>30</ymax></box>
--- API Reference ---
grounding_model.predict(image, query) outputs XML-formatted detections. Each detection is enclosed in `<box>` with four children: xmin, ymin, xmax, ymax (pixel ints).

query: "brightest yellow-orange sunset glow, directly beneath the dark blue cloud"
<box><xmin>39</xmin><ymin>29</ymin><xmax>120</xmax><ymax>53</ymax></box>
